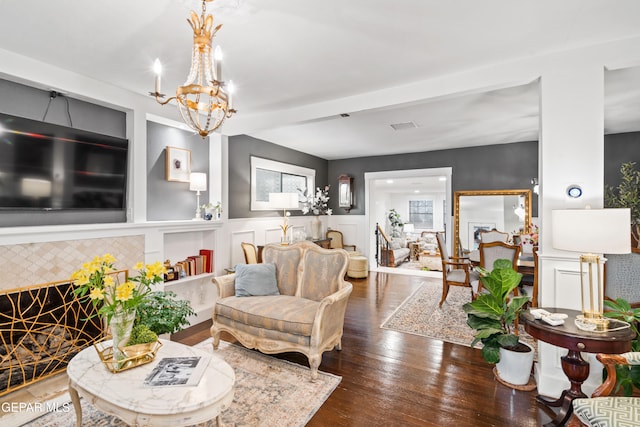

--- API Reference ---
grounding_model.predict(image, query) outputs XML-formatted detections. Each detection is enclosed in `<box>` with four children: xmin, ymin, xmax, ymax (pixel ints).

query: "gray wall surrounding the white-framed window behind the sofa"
<box><xmin>228</xmin><ymin>135</ymin><xmax>328</xmax><ymax>218</ymax></box>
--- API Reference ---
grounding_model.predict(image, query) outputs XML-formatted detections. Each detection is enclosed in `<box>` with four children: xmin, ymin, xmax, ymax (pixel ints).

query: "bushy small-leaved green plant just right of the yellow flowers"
<box><xmin>136</xmin><ymin>291</ymin><xmax>195</xmax><ymax>335</ymax></box>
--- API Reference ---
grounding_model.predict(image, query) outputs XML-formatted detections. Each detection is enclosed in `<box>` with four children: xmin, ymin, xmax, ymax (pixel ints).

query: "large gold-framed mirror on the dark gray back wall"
<box><xmin>452</xmin><ymin>189</ymin><xmax>531</xmax><ymax>256</ymax></box>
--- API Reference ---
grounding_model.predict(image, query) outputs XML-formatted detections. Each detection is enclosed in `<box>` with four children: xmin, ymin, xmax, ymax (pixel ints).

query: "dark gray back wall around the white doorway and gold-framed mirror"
<box><xmin>328</xmin><ymin>141</ymin><xmax>538</xmax><ymax>216</ymax></box>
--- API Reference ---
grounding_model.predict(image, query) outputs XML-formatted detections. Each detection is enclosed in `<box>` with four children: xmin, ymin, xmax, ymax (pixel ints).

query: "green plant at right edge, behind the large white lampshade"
<box><xmin>604</xmin><ymin>162</ymin><xmax>640</xmax><ymax>252</ymax></box>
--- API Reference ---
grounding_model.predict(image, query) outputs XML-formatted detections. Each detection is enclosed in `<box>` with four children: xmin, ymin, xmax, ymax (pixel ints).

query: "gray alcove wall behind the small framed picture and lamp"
<box><xmin>147</xmin><ymin>122</ymin><xmax>210</xmax><ymax>221</ymax></box>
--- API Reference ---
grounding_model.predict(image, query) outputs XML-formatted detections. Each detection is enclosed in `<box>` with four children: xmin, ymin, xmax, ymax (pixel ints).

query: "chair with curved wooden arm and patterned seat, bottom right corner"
<box><xmin>567</xmin><ymin>352</ymin><xmax>640</xmax><ymax>427</ymax></box>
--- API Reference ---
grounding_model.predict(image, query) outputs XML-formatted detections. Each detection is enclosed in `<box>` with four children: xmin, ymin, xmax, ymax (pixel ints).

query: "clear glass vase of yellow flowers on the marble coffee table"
<box><xmin>71</xmin><ymin>254</ymin><xmax>165</xmax><ymax>360</ymax></box>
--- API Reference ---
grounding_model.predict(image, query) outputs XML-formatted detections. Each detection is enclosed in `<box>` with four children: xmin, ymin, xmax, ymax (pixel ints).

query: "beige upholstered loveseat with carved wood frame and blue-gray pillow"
<box><xmin>211</xmin><ymin>241</ymin><xmax>353</xmax><ymax>379</ymax></box>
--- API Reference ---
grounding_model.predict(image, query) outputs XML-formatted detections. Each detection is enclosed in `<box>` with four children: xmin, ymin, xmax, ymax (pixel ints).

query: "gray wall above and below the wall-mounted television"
<box><xmin>0</xmin><ymin>79</ymin><xmax>131</xmax><ymax>227</ymax></box>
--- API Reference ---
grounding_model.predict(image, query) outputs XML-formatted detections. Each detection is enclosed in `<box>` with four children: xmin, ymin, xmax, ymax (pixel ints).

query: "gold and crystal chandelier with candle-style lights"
<box><xmin>149</xmin><ymin>0</ymin><xmax>236</xmax><ymax>139</ymax></box>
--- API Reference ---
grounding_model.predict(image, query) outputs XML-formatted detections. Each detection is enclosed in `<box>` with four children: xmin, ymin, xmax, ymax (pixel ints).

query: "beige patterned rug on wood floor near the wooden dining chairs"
<box><xmin>380</xmin><ymin>279</ymin><xmax>537</xmax><ymax>349</ymax></box>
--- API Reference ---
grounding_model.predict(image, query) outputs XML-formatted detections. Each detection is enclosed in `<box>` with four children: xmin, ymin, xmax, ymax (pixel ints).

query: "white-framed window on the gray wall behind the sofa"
<box><xmin>251</xmin><ymin>156</ymin><xmax>316</xmax><ymax>211</ymax></box>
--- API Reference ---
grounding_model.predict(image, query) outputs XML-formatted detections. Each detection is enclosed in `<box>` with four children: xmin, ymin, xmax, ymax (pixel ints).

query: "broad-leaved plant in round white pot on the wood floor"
<box><xmin>462</xmin><ymin>259</ymin><xmax>533</xmax><ymax>385</ymax></box>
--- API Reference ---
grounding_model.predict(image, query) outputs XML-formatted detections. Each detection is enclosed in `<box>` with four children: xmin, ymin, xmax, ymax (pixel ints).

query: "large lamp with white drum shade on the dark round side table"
<box><xmin>551</xmin><ymin>208</ymin><xmax>631</xmax><ymax>331</ymax></box>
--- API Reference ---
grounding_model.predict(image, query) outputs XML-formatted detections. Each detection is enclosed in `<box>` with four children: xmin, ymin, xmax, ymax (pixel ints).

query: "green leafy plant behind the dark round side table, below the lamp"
<box><xmin>603</xmin><ymin>298</ymin><xmax>640</xmax><ymax>396</ymax></box>
